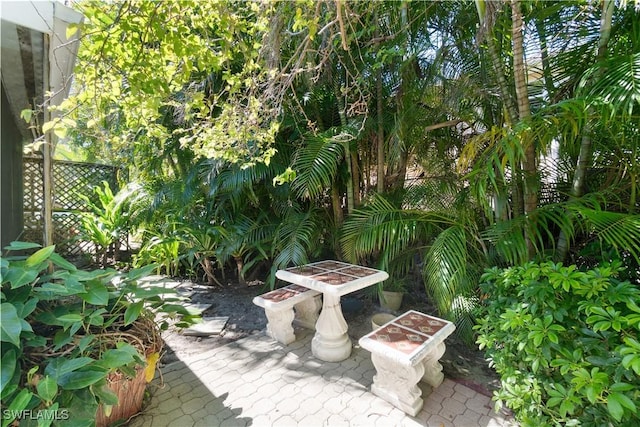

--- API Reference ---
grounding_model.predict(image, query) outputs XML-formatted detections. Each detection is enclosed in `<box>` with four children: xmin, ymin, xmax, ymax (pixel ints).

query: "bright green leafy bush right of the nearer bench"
<box><xmin>475</xmin><ymin>262</ymin><xmax>640</xmax><ymax>426</ymax></box>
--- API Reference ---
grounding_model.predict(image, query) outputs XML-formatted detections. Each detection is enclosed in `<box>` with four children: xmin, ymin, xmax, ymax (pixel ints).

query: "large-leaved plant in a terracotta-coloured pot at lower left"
<box><xmin>0</xmin><ymin>242</ymin><xmax>193</xmax><ymax>427</ymax></box>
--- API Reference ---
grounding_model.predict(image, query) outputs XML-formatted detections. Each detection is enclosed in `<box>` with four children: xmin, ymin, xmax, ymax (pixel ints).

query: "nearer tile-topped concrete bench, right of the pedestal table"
<box><xmin>359</xmin><ymin>310</ymin><xmax>455</xmax><ymax>416</ymax></box>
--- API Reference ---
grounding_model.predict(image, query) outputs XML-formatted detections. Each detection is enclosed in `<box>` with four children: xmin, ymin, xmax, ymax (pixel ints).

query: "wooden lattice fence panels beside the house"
<box><xmin>21</xmin><ymin>157</ymin><xmax>118</xmax><ymax>256</ymax></box>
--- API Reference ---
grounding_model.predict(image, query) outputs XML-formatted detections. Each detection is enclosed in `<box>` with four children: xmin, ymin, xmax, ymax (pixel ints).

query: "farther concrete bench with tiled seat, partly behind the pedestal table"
<box><xmin>253</xmin><ymin>285</ymin><xmax>322</xmax><ymax>345</ymax></box>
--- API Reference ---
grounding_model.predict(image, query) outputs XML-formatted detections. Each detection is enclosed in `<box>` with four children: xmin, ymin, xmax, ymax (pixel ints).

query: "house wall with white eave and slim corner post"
<box><xmin>0</xmin><ymin>0</ymin><xmax>82</xmax><ymax>247</ymax></box>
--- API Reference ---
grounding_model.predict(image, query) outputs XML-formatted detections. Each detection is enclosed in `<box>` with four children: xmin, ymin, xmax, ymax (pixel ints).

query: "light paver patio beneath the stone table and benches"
<box><xmin>129</xmin><ymin>330</ymin><xmax>515</xmax><ymax>427</ymax></box>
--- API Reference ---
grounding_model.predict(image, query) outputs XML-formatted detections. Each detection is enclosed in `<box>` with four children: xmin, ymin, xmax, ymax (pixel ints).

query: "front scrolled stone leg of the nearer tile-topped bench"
<box><xmin>371</xmin><ymin>353</ymin><xmax>425</xmax><ymax>417</ymax></box>
